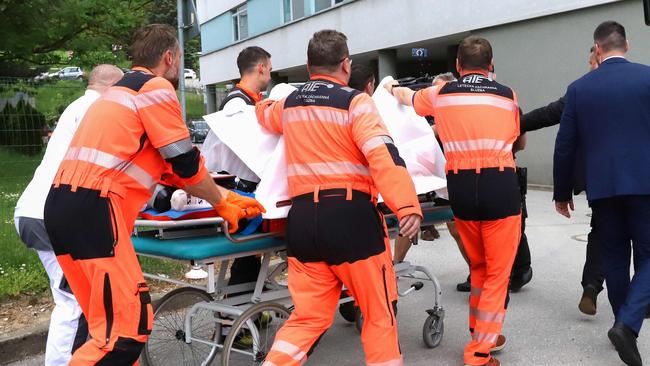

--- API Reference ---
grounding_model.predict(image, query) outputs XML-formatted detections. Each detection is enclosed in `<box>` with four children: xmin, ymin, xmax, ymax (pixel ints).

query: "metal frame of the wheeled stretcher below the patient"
<box><xmin>134</xmin><ymin>202</ymin><xmax>448</xmax><ymax>366</ymax></box>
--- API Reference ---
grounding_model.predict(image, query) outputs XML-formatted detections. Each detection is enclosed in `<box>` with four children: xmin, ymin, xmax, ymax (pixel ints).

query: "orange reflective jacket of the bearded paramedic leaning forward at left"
<box><xmin>54</xmin><ymin>68</ymin><xmax>207</xmax><ymax>225</ymax></box>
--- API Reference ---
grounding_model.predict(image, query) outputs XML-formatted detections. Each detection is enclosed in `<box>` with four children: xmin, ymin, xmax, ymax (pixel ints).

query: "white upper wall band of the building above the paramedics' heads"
<box><xmin>201</xmin><ymin>0</ymin><xmax>617</xmax><ymax>84</ymax></box>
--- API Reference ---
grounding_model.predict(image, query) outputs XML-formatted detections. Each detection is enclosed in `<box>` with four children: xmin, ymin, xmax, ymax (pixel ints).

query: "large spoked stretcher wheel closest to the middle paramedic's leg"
<box><xmin>221</xmin><ymin>302</ymin><xmax>291</xmax><ymax>366</ymax></box>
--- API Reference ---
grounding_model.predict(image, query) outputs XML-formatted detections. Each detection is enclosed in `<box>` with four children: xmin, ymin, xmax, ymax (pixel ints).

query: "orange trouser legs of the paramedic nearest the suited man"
<box><xmin>456</xmin><ymin>215</ymin><xmax>521</xmax><ymax>365</ymax></box>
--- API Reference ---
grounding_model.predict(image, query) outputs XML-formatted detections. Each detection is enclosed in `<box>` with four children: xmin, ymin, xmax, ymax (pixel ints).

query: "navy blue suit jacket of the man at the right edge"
<box><xmin>553</xmin><ymin>57</ymin><xmax>650</xmax><ymax>201</ymax></box>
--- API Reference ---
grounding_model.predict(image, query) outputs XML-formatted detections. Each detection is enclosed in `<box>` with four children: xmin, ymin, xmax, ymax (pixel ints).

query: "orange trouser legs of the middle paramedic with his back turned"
<box><xmin>263</xmin><ymin>251</ymin><xmax>403</xmax><ymax>366</ymax></box>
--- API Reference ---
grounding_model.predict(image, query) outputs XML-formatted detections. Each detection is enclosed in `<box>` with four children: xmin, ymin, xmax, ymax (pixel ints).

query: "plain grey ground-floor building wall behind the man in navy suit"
<box><xmin>473</xmin><ymin>0</ymin><xmax>650</xmax><ymax>185</ymax></box>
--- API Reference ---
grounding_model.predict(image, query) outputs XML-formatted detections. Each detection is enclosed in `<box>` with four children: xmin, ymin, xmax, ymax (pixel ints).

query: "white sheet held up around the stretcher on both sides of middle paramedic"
<box><xmin>204</xmin><ymin>79</ymin><xmax>446</xmax><ymax>219</ymax></box>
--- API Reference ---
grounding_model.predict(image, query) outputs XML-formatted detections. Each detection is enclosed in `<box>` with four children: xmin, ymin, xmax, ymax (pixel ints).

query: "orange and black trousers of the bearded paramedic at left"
<box><xmin>46</xmin><ymin>185</ymin><xmax>153</xmax><ymax>366</ymax></box>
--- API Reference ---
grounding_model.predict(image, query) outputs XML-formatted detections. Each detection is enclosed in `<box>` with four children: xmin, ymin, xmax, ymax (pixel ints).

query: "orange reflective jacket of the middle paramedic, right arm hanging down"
<box><xmin>256</xmin><ymin>75</ymin><xmax>422</xmax><ymax>218</ymax></box>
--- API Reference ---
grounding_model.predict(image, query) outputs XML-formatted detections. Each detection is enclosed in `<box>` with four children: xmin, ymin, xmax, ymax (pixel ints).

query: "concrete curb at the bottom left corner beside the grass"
<box><xmin>0</xmin><ymin>322</ymin><xmax>49</xmax><ymax>365</ymax></box>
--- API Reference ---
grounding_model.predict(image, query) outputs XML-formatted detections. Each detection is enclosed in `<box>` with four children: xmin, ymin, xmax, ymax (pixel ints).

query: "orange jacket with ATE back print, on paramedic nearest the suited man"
<box><xmin>413</xmin><ymin>73</ymin><xmax>519</xmax><ymax>172</ymax></box>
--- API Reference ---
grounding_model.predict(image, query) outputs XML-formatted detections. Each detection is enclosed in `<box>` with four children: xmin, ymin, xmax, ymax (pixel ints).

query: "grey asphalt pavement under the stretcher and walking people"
<box><xmin>7</xmin><ymin>191</ymin><xmax>650</xmax><ymax>366</ymax></box>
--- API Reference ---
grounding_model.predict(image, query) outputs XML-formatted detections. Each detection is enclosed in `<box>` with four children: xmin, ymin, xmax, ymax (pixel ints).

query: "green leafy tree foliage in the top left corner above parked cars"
<box><xmin>0</xmin><ymin>0</ymin><xmax>155</xmax><ymax>74</ymax></box>
